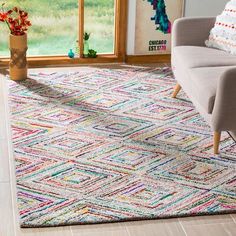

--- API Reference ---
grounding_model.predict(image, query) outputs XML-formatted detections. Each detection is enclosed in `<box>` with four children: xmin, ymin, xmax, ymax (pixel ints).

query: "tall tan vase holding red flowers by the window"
<box><xmin>0</xmin><ymin>3</ymin><xmax>31</xmax><ymax>80</ymax></box>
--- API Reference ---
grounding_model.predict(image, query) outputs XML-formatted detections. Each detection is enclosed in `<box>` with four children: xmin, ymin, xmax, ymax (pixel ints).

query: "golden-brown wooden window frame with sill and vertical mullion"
<box><xmin>0</xmin><ymin>0</ymin><xmax>128</xmax><ymax>67</ymax></box>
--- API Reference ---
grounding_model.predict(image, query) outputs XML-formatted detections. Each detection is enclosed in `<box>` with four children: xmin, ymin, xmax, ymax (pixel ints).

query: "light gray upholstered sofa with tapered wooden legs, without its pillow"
<box><xmin>171</xmin><ymin>17</ymin><xmax>236</xmax><ymax>154</ymax></box>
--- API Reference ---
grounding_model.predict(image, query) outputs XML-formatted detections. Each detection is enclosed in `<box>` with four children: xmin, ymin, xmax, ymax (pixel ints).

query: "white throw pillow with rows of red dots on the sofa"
<box><xmin>206</xmin><ymin>0</ymin><xmax>236</xmax><ymax>55</ymax></box>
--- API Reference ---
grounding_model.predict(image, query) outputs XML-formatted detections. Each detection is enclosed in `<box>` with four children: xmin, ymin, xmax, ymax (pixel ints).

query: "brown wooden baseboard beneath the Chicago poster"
<box><xmin>125</xmin><ymin>54</ymin><xmax>171</xmax><ymax>64</ymax></box>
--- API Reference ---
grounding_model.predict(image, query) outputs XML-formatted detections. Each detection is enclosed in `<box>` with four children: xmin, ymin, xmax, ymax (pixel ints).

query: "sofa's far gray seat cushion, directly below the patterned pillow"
<box><xmin>172</xmin><ymin>46</ymin><xmax>236</xmax><ymax>68</ymax></box>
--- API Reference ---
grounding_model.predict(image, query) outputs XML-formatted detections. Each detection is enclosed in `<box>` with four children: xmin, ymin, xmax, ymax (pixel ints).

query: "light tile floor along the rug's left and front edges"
<box><xmin>0</xmin><ymin>68</ymin><xmax>236</xmax><ymax>236</ymax></box>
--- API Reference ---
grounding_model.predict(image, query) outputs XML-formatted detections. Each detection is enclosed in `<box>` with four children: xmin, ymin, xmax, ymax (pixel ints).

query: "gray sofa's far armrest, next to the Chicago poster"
<box><xmin>172</xmin><ymin>17</ymin><xmax>216</xmax><ymax>48</ymax></box>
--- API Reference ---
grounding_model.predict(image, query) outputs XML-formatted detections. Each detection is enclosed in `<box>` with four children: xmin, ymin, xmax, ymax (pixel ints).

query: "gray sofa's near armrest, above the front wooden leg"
<box><xmin>212</xmin><ymin>67</ymin><xmax>236</xmax><ymax>131</ymax></box>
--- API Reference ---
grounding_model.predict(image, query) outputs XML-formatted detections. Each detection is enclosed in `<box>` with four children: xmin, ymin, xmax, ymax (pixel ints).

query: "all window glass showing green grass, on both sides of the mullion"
<box><xmin>0</xmin><ymin>0</ymin><xmax>125</xmax><ymax>60</ymax></box>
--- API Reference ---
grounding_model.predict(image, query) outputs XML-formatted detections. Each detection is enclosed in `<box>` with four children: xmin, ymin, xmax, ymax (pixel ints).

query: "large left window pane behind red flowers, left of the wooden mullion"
<box><xmin>0</xmin><ymin>0</ymin><xmax>78</xmax><ymax>57</ymax></box>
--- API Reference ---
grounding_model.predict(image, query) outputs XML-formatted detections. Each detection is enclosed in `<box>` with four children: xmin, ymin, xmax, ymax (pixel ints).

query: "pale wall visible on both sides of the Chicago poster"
<box><xmin>127</xmin><ymin>0</ymin><xmax>229</xmax><ymax>55</ymax></box>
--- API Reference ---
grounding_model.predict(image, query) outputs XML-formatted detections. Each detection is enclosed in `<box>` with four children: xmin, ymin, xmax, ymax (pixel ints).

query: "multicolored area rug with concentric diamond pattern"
<box><xmin>9</xmin><ymin>66</ymin><xmax>236</xmax><ymax>227</ymax></box>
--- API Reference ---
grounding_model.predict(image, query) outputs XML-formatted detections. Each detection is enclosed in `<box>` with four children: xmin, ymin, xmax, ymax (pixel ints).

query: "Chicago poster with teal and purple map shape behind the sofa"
<box><xmin>135</xmin><ymin>0</ymin><xmax>184</xmax><ymax>55</ymax></box>
